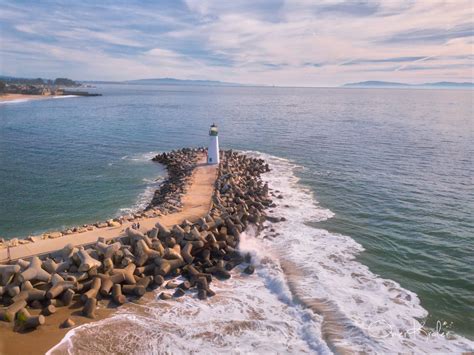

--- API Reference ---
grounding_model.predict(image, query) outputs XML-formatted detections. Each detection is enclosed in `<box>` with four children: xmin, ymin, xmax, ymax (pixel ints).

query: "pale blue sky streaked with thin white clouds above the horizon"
<box><xmin>0</xmin><ymin>0</ymin><xmax>474</xmax><ymax>86</ymax></box>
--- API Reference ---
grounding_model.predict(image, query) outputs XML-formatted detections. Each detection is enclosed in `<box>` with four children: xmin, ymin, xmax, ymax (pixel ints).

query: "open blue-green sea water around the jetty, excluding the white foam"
<box><xmin>0</xmin><ymin>85</ymin><xmax>474</xmax><ymax>338</ymax></box>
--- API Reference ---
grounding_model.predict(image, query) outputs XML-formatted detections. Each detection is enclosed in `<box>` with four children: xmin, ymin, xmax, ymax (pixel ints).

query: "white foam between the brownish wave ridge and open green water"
<box><xmin>246</xmin><ymin>152</ymin><xmax>473</xmax><ymax>353</ymax></box>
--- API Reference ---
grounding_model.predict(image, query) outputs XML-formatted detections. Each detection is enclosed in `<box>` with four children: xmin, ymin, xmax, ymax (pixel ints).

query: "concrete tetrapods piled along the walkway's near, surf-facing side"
<box><xmin>0</xmin><ymin>151</ymin><xmax>273</xmax><ymax>330</ymax></box>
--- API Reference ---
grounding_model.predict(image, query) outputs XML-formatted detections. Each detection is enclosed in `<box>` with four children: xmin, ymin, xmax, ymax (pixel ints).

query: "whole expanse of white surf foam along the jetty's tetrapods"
<box><xmin>49</xmin><ymin>152</ymin><xmax>473</xmax><ymax>354</ymax></box>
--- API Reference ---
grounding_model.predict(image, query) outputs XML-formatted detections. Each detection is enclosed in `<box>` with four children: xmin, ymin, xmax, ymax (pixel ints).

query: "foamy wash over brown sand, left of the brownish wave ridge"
<box><xmin>49</xmin><ymin>241</ymin><xmax>330</xmax><ymax>354</ymax></box>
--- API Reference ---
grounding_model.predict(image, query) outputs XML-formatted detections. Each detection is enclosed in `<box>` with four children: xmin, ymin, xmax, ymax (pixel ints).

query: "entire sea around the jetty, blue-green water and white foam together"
<box><xmin>0</xmin><ymin>85</ymin><xmax>474</xmax><ymax>353</ymax></box>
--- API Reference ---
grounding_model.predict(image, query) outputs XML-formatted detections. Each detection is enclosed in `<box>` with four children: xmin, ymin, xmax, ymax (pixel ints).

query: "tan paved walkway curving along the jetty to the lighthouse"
<box><xmin>0</xmin><ymin>156</ymin><xmax>217</xmax><ymax>263</ymax></box>
